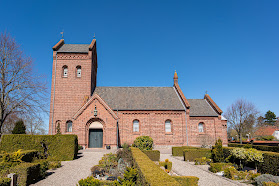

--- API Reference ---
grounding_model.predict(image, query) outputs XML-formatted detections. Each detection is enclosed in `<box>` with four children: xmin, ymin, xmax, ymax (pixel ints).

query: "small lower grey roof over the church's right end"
<box><xmin>188</xmin><ymin>99</ymin><xmax>218</xmax><ymax>116</ymax></box>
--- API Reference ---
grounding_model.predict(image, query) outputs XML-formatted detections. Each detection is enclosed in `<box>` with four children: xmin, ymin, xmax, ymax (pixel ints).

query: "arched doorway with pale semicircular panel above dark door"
<box><xmin>88</xmin><ymin>121</ymin><xmax>103</xmax><ymax>148</ymax></box>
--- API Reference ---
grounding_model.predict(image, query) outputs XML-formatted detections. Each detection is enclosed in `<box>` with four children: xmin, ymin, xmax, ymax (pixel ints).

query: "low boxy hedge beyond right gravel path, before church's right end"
<box><xmin>183</xmin><ymin>148</ymin><xmax>211</xmax><ymax>161</ymax></box>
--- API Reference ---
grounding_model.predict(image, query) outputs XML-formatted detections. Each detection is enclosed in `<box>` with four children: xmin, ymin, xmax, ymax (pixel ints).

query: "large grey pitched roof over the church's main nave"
<box><xmin>94</xmin><ymin>87</ymin><xmax>184</xmax><ymax>110</ymax></box>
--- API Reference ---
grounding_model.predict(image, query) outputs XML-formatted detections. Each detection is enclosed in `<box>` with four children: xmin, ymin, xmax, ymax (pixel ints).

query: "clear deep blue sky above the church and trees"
<box><xmin>0</xmin><ymin>0</ymin><xmax>279</xmax><ymax>125</ymax></box>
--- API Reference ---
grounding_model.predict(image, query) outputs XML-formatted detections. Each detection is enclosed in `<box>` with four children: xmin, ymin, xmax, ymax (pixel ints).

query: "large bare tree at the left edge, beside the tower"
<box><xmin>0</xmin><ymin>33</ymin><xmax>47</xmax><ymax>135</ymax></box>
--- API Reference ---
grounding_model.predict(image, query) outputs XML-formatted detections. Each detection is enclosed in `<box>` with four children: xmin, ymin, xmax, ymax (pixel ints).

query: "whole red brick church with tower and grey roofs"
<box><xmin>49</xmin><ymin>39</ymin><xmax>227</xmax><ymax>148</ymax></box>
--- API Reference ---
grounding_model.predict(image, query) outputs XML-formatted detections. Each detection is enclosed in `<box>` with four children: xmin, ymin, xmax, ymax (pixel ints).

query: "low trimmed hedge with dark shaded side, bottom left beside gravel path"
<box><xmin>9</xmin><ymin>163</ymin><xmax>42</xmax><ymax>186</ymax></box>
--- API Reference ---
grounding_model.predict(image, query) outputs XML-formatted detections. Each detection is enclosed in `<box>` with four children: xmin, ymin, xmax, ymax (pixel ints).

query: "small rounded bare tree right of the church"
<box><xmin>224</xmin><ymin>99</ymin><xmax>258</xmax><ymax>144</ymax></box>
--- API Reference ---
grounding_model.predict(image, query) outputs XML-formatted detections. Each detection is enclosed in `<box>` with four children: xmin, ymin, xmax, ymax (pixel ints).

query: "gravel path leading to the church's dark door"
<box><xmin>33</xmin><ymin>149</ymin><xmax>115</xmax><ymax>186</ymax></box>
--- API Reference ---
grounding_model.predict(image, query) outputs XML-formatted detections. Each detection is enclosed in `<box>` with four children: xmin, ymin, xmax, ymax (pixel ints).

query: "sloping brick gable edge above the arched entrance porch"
<box><xmin>73</xmin><ymin>93</ymin><xmax>119</xmax><ymax>120</ymax></box>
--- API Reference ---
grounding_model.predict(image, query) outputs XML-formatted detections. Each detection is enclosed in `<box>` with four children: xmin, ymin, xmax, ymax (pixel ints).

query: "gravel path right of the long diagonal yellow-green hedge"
<box><xmin>160</xmin><ymin>154</ymin><xmax>246</xmax><ymax>186</ymax></box>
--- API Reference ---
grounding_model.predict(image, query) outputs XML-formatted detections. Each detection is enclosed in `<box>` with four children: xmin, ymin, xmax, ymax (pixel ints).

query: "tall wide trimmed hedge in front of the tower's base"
<box><xmin>0</xmin><ymin>134</ymin><xmax>78</xmax><ymax>161</ymax></box>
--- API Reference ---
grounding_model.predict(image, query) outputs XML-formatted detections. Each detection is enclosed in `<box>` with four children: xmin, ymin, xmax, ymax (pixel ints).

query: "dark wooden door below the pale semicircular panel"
<box><xmin>89</xmin><ymin>129</ymin><xmax>103</xmax><ymax>148</ymax></box>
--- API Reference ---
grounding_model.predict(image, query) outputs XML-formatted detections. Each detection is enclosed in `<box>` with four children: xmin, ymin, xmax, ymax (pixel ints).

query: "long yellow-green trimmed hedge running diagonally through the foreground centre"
<box><xmin>131</xmin><ymin>147</ymin><xmax>199</xmax><ymax>186</ymax></box>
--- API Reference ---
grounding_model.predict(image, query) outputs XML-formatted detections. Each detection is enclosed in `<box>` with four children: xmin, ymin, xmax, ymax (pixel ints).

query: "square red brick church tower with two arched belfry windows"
<box><xmin>49</xmin><ymin>39</ymin><xmax>98</xmax><ymax>134</ymax></box>
